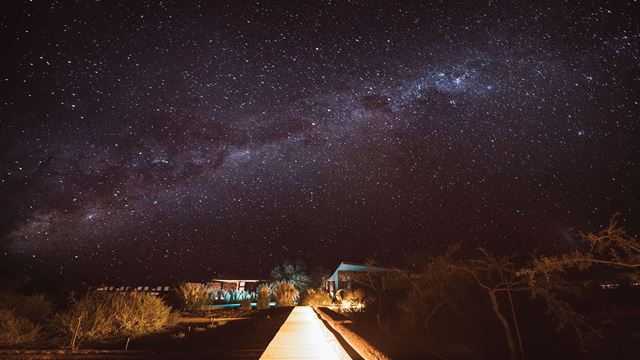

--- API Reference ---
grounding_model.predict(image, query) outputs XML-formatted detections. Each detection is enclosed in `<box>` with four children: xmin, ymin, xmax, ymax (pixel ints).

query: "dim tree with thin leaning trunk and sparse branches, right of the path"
<box><xmin>402</xmin><ymin>246</ymin><xmax>595</xmax><ymax>359</ymax></box>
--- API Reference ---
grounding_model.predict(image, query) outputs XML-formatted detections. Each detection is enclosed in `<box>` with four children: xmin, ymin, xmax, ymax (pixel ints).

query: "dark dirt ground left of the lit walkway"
<box><xmin>0</xmin><ymin>308</ymin><xmax>292</xmax><ymax>360</ymax></box>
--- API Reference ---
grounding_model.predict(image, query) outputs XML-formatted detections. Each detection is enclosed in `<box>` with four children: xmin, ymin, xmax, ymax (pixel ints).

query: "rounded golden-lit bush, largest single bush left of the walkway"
<box><xmin>55</xmin><ymin>292</ymin><xmax>171</xmax><ymax>346</ymax></box>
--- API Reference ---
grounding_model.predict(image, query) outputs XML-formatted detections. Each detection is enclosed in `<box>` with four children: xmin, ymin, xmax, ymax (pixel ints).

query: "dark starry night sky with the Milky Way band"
<box><xmin>0</xmin><ymin>0</ymin><xmax>640</xmax><ymax>284</ymax></box>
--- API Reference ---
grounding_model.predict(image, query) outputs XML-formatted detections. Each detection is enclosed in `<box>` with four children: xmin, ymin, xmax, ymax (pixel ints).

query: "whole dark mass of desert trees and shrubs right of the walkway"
<box><xmin>338</xmin><ymin>217</ymin><xmax>640</xmax><ymax>359</ymax></box>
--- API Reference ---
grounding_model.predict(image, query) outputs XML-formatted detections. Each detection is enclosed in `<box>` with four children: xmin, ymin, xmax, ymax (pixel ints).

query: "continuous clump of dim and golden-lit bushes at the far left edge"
<box><xmin>0</xmin><ymin>292</ymin><xmax>176</xmax><ymax>350</ymax></box>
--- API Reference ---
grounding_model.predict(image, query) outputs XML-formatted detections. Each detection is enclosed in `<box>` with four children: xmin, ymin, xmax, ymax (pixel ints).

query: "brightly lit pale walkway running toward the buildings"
<box><xmin>260</xmin><ymin>306</ymin><xmax>351</xmax><ymax>359</ymax></box>
